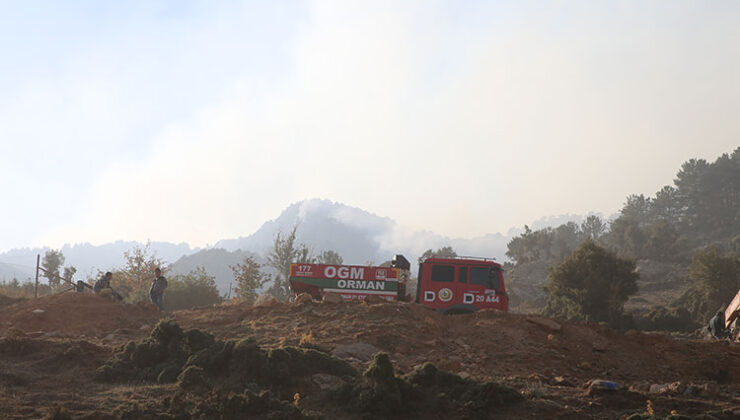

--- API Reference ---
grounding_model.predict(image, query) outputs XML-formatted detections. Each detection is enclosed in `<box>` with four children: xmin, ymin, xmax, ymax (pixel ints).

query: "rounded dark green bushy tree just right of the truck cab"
<box><xmin>545</xmin><ymin>240</ymin><xmax>639</xmax><ymax>327</ymax></box>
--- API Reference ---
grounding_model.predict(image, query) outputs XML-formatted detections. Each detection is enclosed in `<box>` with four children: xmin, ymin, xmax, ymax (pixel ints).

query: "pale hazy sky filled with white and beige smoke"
<box><xmin>0</xmin><ymin>0</ymin><xmax>740</xmax><ymax>251</ymax></box>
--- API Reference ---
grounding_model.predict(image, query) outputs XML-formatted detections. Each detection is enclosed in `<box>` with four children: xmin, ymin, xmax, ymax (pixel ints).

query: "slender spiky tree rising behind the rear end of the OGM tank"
<box><xmin>267</xmin><ymin>225</ymin><xmax>314</xmax><ymax>301</ymax></box>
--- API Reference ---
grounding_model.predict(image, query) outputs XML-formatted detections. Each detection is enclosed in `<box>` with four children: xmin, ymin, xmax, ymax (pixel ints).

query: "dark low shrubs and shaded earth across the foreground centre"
<box><xmin>98</xmin><ymin>320</ymin><xmax>523</xmax><ymax>419</ymax></box>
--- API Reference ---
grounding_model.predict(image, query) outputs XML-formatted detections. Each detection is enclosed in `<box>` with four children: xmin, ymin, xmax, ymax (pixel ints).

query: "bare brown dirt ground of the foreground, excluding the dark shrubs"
<box><xmin>0</xmin><ymin>293</ymin><xmax>740</xmax><ymax>419</ymax></box>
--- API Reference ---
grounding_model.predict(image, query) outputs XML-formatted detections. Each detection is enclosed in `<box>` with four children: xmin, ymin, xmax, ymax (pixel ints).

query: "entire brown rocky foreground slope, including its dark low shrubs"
<box><xmin>0</xmin><ymin>293</ymin><xmax>740</xmax><ymax>419</ymax></box>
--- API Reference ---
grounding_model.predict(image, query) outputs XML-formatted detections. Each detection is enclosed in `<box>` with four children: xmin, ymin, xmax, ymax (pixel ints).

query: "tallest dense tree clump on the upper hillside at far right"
<box><xmin>608</xmin><ymin>147</ymin><xmax>740</xmax><ymax>260</ymax></box>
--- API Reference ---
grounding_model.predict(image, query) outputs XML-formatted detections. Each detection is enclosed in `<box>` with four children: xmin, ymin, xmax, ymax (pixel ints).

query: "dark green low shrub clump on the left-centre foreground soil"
<box><xmin>98</xmin><ymin>320</ymin><xmax>357</xmax><ymax>397</ymax></box>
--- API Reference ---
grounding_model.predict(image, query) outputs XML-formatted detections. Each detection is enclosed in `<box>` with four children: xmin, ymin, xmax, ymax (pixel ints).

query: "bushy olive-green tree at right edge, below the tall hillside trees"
<box><xmin>673</xmin><ymin>245</ymin><xmax>740</xmax><ymax>324</ymax></box>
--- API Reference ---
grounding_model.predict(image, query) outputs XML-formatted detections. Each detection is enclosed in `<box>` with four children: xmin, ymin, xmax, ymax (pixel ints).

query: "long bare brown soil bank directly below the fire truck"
<box><xmin>175</xmin><ymin>301</ymin><xmax>740</xmax><ymax>384</ymax></box>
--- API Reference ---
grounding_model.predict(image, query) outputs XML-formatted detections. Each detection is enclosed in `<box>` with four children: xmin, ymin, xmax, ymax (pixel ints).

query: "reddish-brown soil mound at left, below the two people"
<box><xmin>0</xmin><ymin>293</ymin><xmax>160</xmax><ymax>336</ymax></box>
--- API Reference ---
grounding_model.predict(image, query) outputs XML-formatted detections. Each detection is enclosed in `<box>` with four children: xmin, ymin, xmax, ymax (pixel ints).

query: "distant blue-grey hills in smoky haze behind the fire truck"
<box><xmin>0</xmin><ymin>199</ymin><xmax>580</xmax><ymax>294</ymax></box>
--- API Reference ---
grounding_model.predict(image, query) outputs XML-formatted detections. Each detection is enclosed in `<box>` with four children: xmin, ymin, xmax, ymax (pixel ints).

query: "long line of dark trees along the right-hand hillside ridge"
<box><xmin>506</xmin><ymin>147</ymin><xmax>740</xmax><ymax>264</ymax></box>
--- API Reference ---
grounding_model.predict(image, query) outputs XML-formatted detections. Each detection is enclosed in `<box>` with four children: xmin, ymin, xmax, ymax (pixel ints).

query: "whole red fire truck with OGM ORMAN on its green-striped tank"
<box><xmin>290</xmin><ymin>255</ymin><xmax>509</xmax><ymax>313</ymax></box>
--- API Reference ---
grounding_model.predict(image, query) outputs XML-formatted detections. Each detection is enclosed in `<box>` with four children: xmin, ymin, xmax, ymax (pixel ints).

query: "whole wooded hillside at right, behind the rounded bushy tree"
<box><xmin>506</xmin><ymin>147</ymin><xmax>740</xmax><ymax>330</ymax></box>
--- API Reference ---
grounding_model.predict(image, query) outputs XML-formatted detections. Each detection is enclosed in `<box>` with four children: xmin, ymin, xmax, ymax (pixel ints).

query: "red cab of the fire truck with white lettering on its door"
<box><xmin>416</xmin><ymin>257</ymin><xmax>509</xmax><ymax>313</ymax></box>
